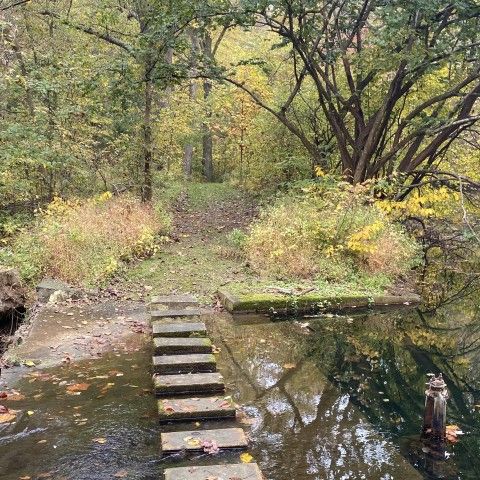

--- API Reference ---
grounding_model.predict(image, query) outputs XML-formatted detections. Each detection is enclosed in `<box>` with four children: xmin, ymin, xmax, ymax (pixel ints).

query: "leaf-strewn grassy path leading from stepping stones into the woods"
<box><xmin>116</xmin><ymin>184</ymin><xmax>257</xmax><ymax>303</ymax></box>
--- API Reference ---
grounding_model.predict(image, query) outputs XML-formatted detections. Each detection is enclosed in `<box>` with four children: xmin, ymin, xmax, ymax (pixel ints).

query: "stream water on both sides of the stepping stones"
<box><xmin>0</xmin><ymin>288</ymin><xmax>480</xmax><ymax>480</ymax></box>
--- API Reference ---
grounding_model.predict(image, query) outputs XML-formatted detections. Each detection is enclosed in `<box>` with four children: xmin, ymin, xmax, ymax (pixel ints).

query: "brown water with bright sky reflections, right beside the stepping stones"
<box><xmin>217</xmin><ymin>323</ymin><xmax>416</xmax><ymax>479</ymax></box>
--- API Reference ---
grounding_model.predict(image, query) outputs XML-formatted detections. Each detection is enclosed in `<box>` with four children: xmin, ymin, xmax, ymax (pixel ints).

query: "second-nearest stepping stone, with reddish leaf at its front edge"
<box><xmin>160</xmin><ymin>428</ymin><xmax>248</xmax><ymax>453</ymax></box>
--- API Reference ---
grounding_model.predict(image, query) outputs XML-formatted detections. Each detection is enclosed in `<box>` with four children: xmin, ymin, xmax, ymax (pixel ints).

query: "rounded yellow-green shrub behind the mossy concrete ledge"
<box><xmin>246</xmin><ymin>182</ymin><xmax>419</xmax><ymax>283</ymax></box>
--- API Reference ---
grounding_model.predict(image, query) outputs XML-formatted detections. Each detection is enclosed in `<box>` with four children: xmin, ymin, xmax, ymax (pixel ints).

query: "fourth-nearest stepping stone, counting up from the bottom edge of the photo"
<box><xmin>153</xmin><ymin>372</ymin><xmax>225</xmax><ymax>396</ymax></box>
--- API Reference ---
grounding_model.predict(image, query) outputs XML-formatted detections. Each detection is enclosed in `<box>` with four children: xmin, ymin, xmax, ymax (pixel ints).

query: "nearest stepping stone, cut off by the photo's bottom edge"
<box><xmin>165</xmin><ymin>463</ymin><xmax>264</xmax><ymax>480</ymax></box>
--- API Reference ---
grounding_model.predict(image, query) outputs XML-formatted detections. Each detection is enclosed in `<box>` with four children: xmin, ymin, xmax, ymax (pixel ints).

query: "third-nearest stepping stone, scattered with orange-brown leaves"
<box><xmin>158</xmin><ymin>397</ymin><xmax>236</xmax><ymax>423</ymax></box>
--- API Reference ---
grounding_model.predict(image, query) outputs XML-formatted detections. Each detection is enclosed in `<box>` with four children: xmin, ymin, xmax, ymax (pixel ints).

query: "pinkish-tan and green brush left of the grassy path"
<box><xmin>0</xmin><ymin>193</ymin><xmax>169</xmax><ymax>286</ymax></box>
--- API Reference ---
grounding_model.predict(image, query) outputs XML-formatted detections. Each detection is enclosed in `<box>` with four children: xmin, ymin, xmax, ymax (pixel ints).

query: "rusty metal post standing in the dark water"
<box><xmin>422</xmin><ymin>373</ymin><xmax>448</xmax><ymax>455</ymax></box>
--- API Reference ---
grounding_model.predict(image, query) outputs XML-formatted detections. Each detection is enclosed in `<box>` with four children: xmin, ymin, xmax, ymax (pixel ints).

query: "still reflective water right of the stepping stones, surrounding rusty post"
<box><xmin>212</xmin><ymin>290</ymin><xmax>480</xmax><ymax>480</ymax></box>
